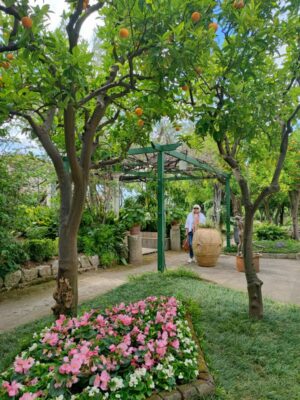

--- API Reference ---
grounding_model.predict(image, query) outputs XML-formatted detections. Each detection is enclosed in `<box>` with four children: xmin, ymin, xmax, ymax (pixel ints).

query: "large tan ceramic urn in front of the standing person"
<box><xmin>193</xmin><ymin>227</ymin><xmax>222</xmax><ymax>267</ymax></box>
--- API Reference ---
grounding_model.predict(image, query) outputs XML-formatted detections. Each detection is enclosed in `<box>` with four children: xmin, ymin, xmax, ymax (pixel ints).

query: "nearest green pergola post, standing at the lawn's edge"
<box><xmin>157</xmin><ymin>151</ymin><xmax>166</xmax><ymax>272</ymax></box>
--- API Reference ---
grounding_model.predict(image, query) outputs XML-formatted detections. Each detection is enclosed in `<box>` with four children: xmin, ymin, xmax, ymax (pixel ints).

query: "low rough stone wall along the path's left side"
<box><xmin>0</xmin><ymin>255</ymin><xmax>99</xmax><ymax>292</ymax></box>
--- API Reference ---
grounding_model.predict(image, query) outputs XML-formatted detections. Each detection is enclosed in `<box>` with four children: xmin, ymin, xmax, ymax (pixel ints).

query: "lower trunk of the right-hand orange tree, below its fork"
<box><xmin>243</xmin><ymin>207</ymin><xmax>263</xmax><ymax>319</ymax></box>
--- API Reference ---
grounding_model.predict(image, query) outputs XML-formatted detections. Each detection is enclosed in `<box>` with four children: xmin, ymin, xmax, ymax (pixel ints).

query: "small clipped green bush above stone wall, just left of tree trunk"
<box><xmin>26</xmin><ymin>239</ymin><xmax>57</xmax><ymax>262</ymax></box>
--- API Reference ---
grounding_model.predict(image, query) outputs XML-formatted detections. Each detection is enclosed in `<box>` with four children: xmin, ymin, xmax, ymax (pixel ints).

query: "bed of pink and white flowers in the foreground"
<box><xmin>0</xmin><ymin>297</ymin><xmax>202</xmax><ymax>400</ymax></box>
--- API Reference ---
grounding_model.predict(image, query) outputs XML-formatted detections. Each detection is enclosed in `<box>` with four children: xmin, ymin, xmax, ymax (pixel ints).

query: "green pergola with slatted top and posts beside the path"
<box><xmin>124</xmin><ymin>143</ymin><xmax>230</xmax><ymax>272</ymax></box>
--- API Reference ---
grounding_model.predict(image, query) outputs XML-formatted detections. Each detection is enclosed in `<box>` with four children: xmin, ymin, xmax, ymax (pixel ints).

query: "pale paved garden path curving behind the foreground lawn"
<box><xmin>0</xmin><ymin>255</ymin><xmax>300</xmax><ymax>333</ymax></box>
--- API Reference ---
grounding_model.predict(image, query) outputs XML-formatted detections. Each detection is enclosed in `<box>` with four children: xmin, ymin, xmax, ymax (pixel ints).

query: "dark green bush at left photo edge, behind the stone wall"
<box><xmin>0</xmin><ymin>232</ymin><xmax>29</xmax><ymax>278</ymax></box>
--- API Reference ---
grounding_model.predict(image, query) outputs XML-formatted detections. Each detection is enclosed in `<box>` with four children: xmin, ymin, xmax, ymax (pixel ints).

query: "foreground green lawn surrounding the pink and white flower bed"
<box><xmin>0</xmin><ymin>269</ymin><xmax>300</xmax><ymax>400</ymax></box>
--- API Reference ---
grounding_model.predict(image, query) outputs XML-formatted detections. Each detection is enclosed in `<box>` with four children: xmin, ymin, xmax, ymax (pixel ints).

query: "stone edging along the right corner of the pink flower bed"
<box><xmin>147</xmin><ymin>315</ymin><xmax>215</xmax><ymax>400</ymax></box>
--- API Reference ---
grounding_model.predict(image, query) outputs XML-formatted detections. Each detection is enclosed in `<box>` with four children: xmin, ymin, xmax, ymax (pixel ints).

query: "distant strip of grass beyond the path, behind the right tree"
<box><xmin>223</xmin><ymin>239</ymin><xmax>300</xmax><ymax>254</ymax></box>
